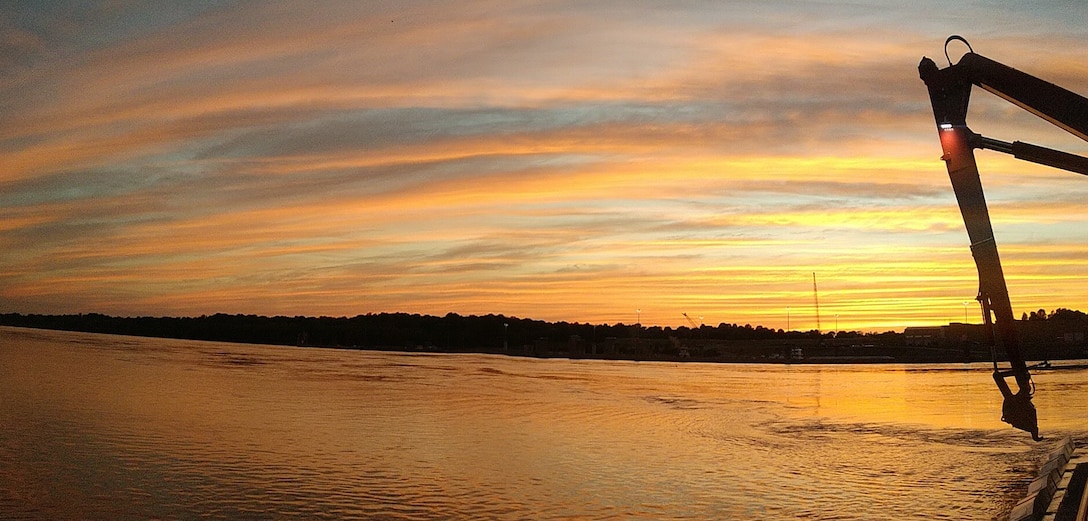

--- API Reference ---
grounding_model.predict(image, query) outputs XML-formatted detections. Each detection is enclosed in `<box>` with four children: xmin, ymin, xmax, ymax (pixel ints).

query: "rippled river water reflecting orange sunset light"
<box><xmin>0</xmin><ymin>327</ymin><xmax>1088</xmax><ymax>520</ymax></box>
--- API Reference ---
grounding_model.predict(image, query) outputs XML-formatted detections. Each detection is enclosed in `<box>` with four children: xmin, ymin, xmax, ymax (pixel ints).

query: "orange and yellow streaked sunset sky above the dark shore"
<box><xmin>0</xmin><ymin>0</ymin><xmax>1088</xmax><ymax>331</ymax></box>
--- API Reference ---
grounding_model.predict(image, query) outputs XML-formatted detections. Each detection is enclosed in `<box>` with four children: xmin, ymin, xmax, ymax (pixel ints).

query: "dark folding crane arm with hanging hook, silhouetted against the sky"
<box><xmin>918</xmin><ymin>36</ymin><xmax>1088</xmax><ymax>439</ymax></box>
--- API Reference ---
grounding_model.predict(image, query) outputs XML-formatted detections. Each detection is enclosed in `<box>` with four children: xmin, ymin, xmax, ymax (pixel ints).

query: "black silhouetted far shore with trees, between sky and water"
<box><xmin>0</xmin><ymin>313</ymin><xmax>1088</xmax><ymax>364</ymax></box>
